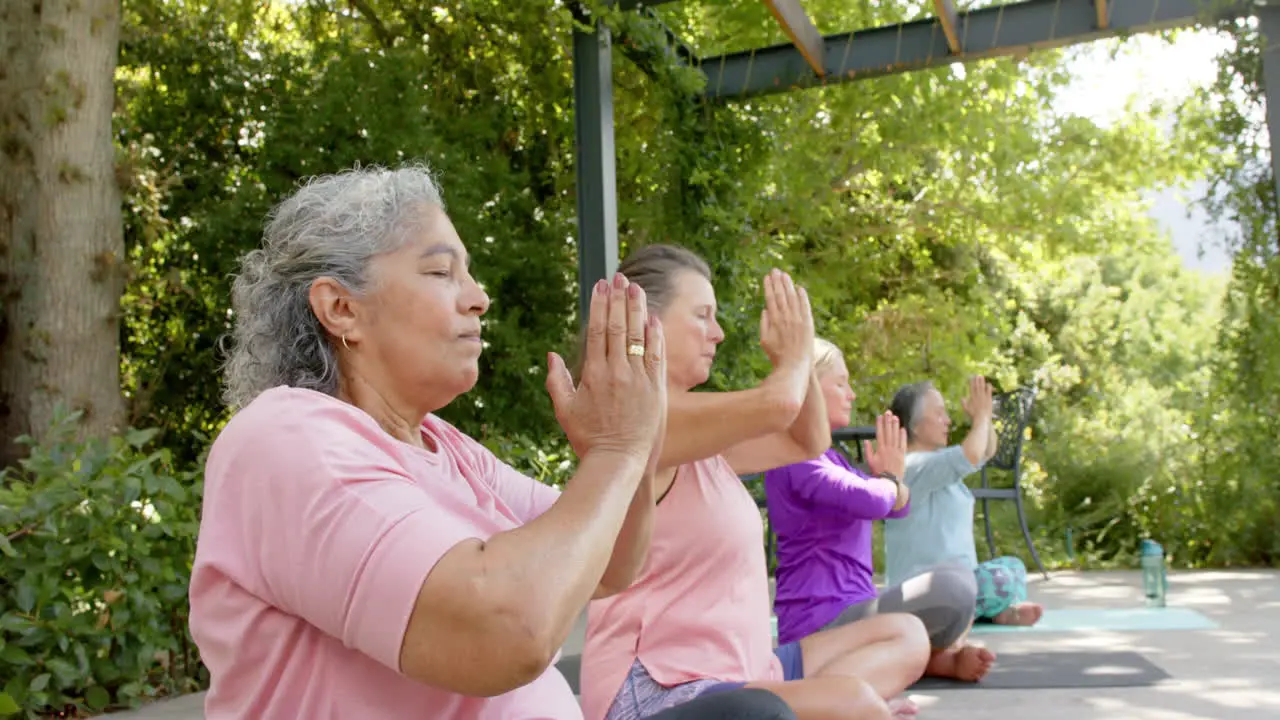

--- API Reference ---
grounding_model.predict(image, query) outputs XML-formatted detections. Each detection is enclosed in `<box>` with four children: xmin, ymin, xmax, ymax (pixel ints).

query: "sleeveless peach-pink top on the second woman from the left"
<box><xmin>581</xmin><ymin>456</ymin><xmax>782</xmax><ymax>720</ymax></box>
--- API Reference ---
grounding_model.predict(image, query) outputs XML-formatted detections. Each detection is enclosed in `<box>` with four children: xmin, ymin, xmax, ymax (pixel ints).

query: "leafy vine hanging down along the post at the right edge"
<box><xmin>1179</xmin><ymin>20</ymin><xmax>1280</xmax><ymax>564</ymax></box>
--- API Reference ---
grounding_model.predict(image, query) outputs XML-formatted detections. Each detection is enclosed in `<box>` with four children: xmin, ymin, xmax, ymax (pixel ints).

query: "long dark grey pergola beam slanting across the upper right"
<box><xmin>701</xmin><ymin>0</ymin><xmax>1253</xmax><ymax>99</ymax></box>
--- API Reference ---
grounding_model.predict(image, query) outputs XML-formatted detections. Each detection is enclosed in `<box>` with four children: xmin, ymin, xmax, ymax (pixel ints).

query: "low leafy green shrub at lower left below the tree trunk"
<box><xmin>0</xmin><ymin>414</ymin><xmax>206</xmax><ymax>717</ymax></box>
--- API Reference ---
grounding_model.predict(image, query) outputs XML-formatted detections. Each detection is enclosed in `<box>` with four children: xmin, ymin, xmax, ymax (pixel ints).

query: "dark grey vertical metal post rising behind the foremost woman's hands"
<box><xmin>573</xmin><ymin>24</ymin><xmax>618</xmax><ymax>325</ymax></box>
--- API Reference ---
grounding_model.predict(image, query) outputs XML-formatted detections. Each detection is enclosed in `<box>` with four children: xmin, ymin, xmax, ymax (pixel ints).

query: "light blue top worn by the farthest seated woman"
<box><xmin>884</xmin><ymin>445</ymin><xmax>978</xmax><ymax>585</ymax></box>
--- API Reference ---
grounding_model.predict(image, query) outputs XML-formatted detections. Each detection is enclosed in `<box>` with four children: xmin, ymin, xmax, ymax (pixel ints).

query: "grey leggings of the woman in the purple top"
<box><xmin>823</xmin><ymin>565</ymin><xmax>978</xmax><ymax>650</ymax></box>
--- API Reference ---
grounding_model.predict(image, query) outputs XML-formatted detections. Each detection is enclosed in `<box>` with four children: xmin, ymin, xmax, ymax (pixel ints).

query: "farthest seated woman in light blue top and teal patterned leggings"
<box><xmin>884</xmin><ymin>377</ymin><xmax>1044</xmax><ymax>625</ymax></box>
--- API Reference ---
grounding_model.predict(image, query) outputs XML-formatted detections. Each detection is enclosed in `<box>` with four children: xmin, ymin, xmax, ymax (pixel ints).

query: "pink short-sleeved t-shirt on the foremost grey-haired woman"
<box><xmin>191</xmin><ymin>387</ymin><xmax>582</xmax><ymax>720</ymax></box>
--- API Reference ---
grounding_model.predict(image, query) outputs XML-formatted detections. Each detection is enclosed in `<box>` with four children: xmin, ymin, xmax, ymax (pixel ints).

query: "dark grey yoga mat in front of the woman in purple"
<box><xmin>908</xmin><ymin>651</ymin><xmax>1170</xmax><ymax>692</ymax></box>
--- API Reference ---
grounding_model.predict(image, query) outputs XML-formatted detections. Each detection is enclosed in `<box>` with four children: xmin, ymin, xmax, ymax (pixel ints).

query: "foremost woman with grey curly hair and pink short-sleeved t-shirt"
<box><xmin>191</xmin><ymin>168</ymin><xmax>794</xmax><ymax>720</ymax></box>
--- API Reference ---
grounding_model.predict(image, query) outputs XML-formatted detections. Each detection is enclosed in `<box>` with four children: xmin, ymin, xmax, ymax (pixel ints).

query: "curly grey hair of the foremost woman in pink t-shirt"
<box><xmin>223</xmin><ymin>167</ymin><xmax>444</xmax><ymax>409</ymax></box>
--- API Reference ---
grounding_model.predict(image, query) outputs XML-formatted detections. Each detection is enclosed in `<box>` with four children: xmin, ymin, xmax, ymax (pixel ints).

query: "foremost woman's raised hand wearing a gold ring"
<box><xmin>547</xmin><ymin>274</ymin><xmax>667</xmax><ymax>465</ymax></box>
